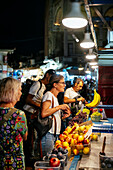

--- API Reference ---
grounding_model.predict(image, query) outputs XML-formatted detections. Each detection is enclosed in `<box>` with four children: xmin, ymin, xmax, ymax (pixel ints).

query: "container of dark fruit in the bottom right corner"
<box><xmin>99</xmin><ymin>152</ymin><xmax>113</xmax><ymax>170</ymax></box>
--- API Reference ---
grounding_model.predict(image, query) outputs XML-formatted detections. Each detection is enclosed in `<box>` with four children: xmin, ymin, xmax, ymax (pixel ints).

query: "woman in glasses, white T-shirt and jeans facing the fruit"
<box><xmin>41</xmin><ymin>75</ymin><xmax>71</xmax><ymax>156</ymax></box>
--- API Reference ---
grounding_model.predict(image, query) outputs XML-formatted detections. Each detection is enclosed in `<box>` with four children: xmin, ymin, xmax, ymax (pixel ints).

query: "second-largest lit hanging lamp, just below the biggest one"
<box><xmin>80</xmin><ymin>32</ymin><xmax>95</xmax><ymax>49</ymax></box>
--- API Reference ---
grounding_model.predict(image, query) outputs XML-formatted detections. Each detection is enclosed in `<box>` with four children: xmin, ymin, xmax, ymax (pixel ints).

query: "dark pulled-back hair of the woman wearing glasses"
<box><xmin>49</xmin><ymin>74</ymin><xmax>64</xmax><ymax>89</ymax></box>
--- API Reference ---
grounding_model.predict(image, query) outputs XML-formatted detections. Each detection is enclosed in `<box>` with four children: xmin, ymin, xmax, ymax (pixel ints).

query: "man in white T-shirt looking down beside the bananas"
<box><xmin>64</xmin><ymin>78</ymin><xmax>87</xmax><ymax>117</ymax></box>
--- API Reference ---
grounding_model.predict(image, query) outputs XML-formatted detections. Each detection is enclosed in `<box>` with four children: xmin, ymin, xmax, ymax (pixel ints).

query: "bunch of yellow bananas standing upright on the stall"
<box><xmin>86</xmin><ymin>89</ymin><xmax>101</xmax><ymax>107</ymax></box>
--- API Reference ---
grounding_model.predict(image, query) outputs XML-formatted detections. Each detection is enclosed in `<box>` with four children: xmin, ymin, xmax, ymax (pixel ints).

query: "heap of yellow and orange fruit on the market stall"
<box><xmin>55</xmin><ymin>123</ymin><xmax>92</xmax><ymax>157</ymax></box>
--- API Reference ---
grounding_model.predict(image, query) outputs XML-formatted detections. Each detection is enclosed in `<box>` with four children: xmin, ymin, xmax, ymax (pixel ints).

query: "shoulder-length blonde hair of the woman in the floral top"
<box><xmin>0</xmin><ymin>77</ymin><xmax>21</xmax><ymax>103</ymax></box>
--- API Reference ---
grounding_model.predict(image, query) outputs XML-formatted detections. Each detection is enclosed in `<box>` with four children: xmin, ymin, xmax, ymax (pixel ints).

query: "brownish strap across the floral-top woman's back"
<box><xmin>0</xmin><ymin>108</ymin><xmax>17</xmax><ymax>126</ymax></box>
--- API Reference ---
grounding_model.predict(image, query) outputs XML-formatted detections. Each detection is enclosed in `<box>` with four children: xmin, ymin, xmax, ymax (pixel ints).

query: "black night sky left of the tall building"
<box><xmin>0</xmin><ymin>0</ymin><xmax>45</xmax><ymax>53</ymax></box>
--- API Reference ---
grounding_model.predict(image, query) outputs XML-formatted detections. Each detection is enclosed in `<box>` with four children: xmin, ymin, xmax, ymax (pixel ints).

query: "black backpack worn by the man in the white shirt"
<box><xmin>15</xmin><ymin>80</ymin><xmax>42</xmax><ymax>110</ymax></box>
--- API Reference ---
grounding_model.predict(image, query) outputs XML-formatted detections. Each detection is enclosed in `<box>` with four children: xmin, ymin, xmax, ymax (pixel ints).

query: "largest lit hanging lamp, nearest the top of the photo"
<box><xmin>62</xmin><ymin>2</ymin><xmax>88</xmax><ymax>29</ymax></box>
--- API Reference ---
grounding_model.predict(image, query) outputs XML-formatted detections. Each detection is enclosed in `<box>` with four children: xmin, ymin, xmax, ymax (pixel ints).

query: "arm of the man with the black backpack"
<box><xmin>26</xmin><ymin>94</ymin><xmax>40</xmax><ymax>107</ymax></box>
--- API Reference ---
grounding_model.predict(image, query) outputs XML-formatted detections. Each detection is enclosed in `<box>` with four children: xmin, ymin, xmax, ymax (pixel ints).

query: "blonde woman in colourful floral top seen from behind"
<box><xmin>0</xmin><ymin>77</ymin><xmax>28</xmax><ymax>170</ymax></box>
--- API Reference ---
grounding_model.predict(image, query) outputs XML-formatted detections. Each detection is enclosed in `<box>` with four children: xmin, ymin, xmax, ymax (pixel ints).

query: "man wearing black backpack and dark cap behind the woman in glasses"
<box><xmin>23</xmin><ymin>69</ymin><xmax>55</xmax><ymax>164</ymax></box>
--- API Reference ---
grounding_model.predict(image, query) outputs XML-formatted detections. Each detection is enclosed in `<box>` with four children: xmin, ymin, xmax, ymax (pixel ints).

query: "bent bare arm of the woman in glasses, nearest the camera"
<box><xmin>41</xmin><ymin>100</ymin><xmax>71</xmax><ymax>118</ymax></box>
